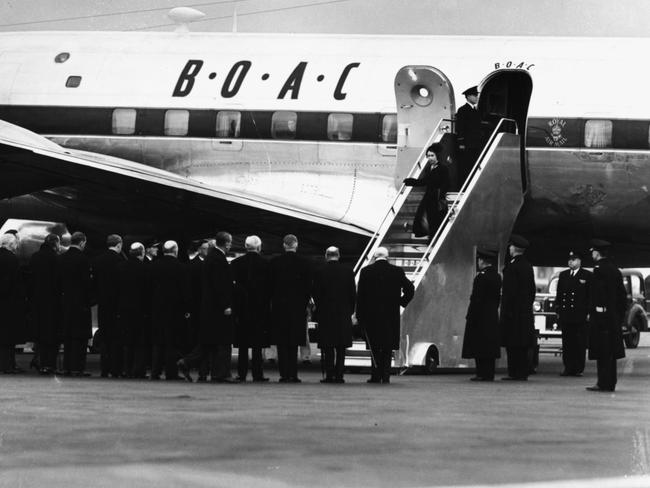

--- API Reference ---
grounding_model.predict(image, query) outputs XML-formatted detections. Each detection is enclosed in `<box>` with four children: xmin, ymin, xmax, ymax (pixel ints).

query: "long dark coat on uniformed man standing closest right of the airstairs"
<box><xmin>462</xmin><ymin>266</ymin><xmax>501</xmax><ymax>359</ymax></box>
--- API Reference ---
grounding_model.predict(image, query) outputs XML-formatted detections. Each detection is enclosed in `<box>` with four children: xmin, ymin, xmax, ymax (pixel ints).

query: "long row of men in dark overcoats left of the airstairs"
<box><xmin>0</xmin><ymin>232</ymin><xmax>413</xmax><ymax>383</ymax></box>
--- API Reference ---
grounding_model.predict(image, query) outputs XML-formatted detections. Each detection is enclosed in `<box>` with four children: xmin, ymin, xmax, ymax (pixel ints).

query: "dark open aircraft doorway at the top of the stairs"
<box><xmin>477</xmin><ymin>69</ymin><xmax>533</xmax><ymax>191</ymax></box>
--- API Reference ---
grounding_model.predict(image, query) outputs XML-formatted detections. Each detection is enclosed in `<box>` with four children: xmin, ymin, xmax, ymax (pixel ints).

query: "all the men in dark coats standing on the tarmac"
<box><xmin>0</xmin><ymin>227</ymin><xmax>626</xmax><ymax>391</ymax></box>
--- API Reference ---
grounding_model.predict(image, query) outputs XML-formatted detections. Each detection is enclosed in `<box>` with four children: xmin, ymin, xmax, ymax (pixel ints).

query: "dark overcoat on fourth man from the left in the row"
<box><xmin>92</xmin><ymin>249</ymin><xmax>124</xmax><ymax>340</ymax></box>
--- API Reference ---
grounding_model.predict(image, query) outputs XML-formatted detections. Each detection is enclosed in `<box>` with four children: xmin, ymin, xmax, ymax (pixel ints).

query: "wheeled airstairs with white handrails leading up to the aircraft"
<box><xmin>346</xmin><ymin>68</ymin><xmax>532</xmax><ymax>371</ymax></box>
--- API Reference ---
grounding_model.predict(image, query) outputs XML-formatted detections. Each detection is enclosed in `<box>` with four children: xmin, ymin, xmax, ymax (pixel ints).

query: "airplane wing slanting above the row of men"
<box><xmin>0</xmin><ymin>121</ymin><xmax>371</xmax><ymax>254</ymax></box>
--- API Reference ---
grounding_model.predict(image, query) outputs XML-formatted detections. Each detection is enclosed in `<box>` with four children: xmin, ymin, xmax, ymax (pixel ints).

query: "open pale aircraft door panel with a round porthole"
<box><xmin>395</xmin><ymin>66</ymin><xmax>456</xmax><ymax>188</ymax></box>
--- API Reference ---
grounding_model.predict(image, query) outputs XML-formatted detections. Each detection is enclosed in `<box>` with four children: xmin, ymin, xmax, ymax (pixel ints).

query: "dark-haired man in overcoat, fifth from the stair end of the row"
<box><xmin>199</xmin><ymin>232</ymin><xmax>234</xmax><ymax>383</ymax></box>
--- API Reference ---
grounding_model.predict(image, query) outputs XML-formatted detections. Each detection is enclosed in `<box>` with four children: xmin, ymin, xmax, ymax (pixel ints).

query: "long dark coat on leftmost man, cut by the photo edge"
<box><xmin>0</xmin><ymin>248</ymin><xmax>27</xmax><ymax>345</ymax></box>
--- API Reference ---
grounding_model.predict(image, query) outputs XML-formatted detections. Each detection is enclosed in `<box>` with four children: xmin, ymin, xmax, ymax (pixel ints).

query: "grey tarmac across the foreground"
<box><xmin>0</xmin><ymin>333</ymin><xmax>650</xmax><ymax>488</ymax></box>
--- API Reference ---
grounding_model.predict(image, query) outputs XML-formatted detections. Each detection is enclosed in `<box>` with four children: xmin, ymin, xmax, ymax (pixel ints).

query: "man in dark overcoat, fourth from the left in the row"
<box><xmin>92</xmin><ymin>234</ymin><xmax>124</xmax><ymax>378</ymax></box>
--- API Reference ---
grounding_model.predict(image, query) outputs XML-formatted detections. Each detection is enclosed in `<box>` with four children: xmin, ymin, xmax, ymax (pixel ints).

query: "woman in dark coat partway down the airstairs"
<box><xmin>404</xmin><ymin>142</ymin><xmax>449</xmax><ymax>237</ymax></box>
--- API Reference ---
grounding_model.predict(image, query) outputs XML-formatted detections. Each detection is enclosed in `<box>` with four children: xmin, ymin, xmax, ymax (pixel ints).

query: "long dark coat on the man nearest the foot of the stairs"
<box><xmin>357</xmin><ymin>259</ymin><xmax>415</xmax><ymax>349</ymax></box>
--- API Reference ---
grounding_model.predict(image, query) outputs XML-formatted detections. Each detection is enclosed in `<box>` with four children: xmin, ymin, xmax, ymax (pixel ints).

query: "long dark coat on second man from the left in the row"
<box><xmin>29</xmin><ymin>245</ymin><xmax>61</xmax><ymax>344</ymax></box>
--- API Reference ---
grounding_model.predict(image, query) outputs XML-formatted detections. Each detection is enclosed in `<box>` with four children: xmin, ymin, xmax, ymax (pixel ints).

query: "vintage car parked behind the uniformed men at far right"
<box><xmin>533</xmin><ymin>269</ymin><xmax>650</xmax><ymax>354</ymax></box>
